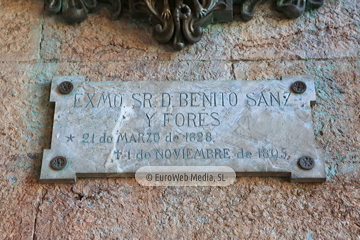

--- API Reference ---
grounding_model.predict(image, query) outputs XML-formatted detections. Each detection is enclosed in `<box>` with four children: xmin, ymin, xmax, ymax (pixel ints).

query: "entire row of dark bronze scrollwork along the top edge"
<box><xmin>46</xmin><ymin>0</ymin><xmax>324</xmax><ymax>50</ymax></box>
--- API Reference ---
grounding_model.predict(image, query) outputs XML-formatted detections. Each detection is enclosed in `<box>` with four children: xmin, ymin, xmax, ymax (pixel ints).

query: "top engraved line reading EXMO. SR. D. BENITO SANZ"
<box><xmin>74</xmin><ymin>92</ymin><xmax>291</xmax><ymax>108</ymax></box>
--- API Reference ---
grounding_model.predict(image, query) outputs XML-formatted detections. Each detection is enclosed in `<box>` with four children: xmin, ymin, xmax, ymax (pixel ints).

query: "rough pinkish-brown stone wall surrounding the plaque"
<box><xmin>0</xmin><ymin>0</ymin><xmax>360</xmax><ymax>239</ymax></box>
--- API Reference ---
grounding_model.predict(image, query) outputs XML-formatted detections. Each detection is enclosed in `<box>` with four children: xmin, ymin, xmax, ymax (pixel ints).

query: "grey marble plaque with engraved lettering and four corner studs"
<box><xmin>40</xmin><ymin>76</ymin><xmax>326</xmax><ymax>182</ymax></box>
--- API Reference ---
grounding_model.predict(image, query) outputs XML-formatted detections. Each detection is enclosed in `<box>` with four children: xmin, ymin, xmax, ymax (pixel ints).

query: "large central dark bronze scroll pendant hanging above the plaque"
<box><xmin>134</xmin><ymin>0</ymin><xmax>226</xmax><ymax>50</ymax></box>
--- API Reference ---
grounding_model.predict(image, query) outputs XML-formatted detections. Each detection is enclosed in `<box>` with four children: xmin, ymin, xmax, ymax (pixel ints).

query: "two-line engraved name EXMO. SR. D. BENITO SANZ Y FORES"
<box><xmin>73</xmin><ymin>91</ymin><xmax>291</xmax><ymax>127</ymax></box>
